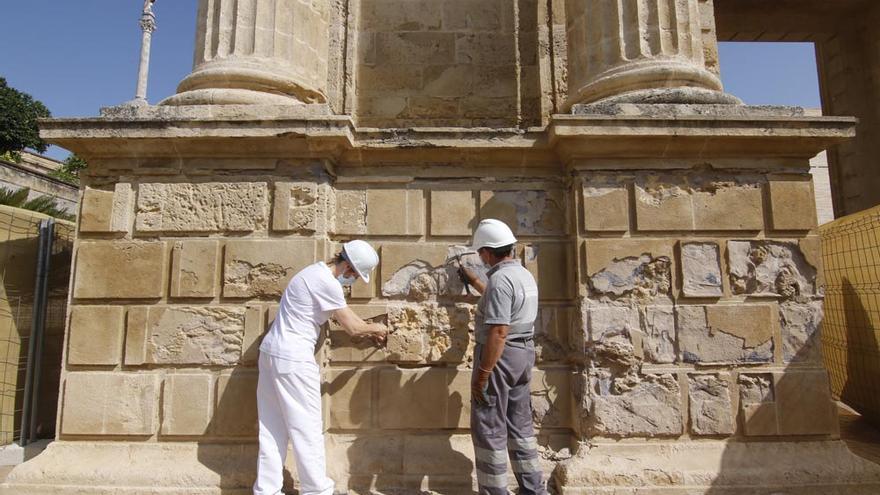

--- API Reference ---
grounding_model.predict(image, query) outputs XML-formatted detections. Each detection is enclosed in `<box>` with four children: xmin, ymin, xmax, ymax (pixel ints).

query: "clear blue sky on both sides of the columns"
<box><xmin>0</xmin><ymin>0</ymin><xmax>820</xmax><ymax>159</ymax></box>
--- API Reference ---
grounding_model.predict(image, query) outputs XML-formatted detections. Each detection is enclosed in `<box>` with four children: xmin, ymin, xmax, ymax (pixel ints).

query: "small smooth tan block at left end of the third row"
<box><xmin>67</xmin><ymin>306</ymin><xmax>125</xmax><ymax>365</ymax></box>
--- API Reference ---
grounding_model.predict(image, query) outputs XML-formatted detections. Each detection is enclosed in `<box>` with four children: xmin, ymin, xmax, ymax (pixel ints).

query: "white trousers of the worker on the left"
<box><xmin>254</xmin><ymin>353</ymin><xmax>334</xmax><ymax>495</ymax></box>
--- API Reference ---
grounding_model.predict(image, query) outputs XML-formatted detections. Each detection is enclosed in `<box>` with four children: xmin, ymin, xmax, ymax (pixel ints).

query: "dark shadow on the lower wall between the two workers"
<box><xmin>327</xmin><ymin>367</ymin><xmax>473</xmax><ymax>494</ymax></box>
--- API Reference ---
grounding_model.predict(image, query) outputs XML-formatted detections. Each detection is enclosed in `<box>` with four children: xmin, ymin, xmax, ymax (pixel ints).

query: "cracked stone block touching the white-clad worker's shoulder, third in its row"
<box><xmin>223</xmin><ymin>239</ymin><xmax>319</xmax><ymax>299</ymax></box>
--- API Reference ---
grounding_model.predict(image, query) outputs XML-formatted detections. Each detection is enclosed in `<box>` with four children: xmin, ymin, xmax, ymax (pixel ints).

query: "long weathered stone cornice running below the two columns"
<box><xmin>41</xmin><ymin>105</ymin><xmax>857</xmax><ymax>166</ymax></box>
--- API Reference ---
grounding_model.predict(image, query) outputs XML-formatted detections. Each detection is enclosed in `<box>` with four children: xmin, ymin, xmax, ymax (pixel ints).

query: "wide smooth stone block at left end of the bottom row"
<box><xmin>61</xmin><ymin>371</ymin><xmax>160</xmax><ymax>436</ymax></box>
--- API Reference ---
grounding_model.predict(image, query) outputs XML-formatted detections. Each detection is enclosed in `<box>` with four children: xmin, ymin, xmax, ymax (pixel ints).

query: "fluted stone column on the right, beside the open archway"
<box><xmin>565</xmin><ymin>0</ymin><xmax>739</xmax><ymax>108</ymax></box>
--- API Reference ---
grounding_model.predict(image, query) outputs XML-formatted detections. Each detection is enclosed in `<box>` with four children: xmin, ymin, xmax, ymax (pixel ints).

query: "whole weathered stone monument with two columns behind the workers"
<box><xmin>6</xmin><ymin>0</ymin><xmax>880</xmax><ymax>495</ymax></box>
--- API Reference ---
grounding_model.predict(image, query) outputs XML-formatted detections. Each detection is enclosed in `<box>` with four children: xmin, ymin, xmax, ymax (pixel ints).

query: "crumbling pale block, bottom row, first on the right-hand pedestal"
<box><xmin>575</xmin><ymin>370</ymin><xmax>683</xmax><ymax>437</ymax></box>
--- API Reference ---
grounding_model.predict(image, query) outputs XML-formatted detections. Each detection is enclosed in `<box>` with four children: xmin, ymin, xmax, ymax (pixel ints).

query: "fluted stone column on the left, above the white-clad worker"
<box><xmin>161</xmin><ymin>0</ymin><xmax>330</xmax><ymax>105</ymax></box>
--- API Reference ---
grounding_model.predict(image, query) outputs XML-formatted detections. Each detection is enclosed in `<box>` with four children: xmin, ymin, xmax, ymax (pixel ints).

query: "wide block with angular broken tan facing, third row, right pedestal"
<box><xmin>676</xmin><ymin>304</ymin><xmax>778</xmax><ymax>364</ymax></box>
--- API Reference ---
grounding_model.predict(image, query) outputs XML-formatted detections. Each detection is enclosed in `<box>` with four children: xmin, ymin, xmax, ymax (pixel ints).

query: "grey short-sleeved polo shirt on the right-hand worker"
<box><xmin>474</xmin><ymin>260</ymin><xmax>538</xmax><ymax>344</ymax></box>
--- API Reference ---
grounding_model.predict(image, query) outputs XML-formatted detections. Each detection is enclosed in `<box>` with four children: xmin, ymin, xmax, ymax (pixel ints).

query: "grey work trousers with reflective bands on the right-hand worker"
<box><xmin>471</xmin><ymin>341</ymin><xmax>547</xmax><ymax>495</ymax></box>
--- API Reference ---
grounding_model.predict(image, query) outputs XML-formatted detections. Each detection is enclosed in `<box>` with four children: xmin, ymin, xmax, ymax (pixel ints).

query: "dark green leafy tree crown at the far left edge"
<box><xmin>0</xmin><ymin>77</ymin><xmax>51</xmax><ymax>162</ymax></box>
